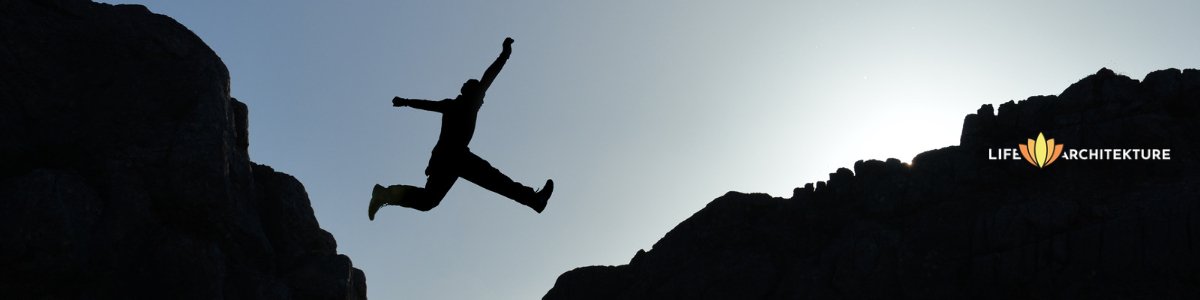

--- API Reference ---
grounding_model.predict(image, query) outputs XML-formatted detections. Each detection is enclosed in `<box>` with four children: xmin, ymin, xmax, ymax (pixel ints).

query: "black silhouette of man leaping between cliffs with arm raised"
<box><xmin>367</xmin><ymin>37</ymin><xmax>554</xmax><ymax>221</ymax></box>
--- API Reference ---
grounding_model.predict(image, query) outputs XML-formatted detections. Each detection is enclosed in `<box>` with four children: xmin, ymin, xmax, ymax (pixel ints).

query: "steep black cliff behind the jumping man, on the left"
<box><xmin>0</xmin><ymin>0</ymin><xmax>366</xmax><ymax>299</ymax></box>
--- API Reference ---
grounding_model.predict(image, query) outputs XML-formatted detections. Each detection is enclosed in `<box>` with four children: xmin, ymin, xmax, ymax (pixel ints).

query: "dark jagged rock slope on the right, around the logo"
<box><xmin>544</xmin><ymin>70</ymin><xmax>1200</xmax><ymax>299</ymax></box>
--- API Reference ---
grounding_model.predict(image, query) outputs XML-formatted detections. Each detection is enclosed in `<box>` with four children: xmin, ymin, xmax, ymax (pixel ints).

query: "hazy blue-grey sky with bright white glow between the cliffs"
<box><xmin>100</xmin><ymin>0</ymin><xmax>1200</xmax><ymax>299</ymax></box>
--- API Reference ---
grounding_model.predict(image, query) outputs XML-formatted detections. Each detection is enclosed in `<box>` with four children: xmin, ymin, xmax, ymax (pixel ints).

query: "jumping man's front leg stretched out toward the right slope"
<box><xmin>458</xmin><ymin>152</ymin><xmax>553</xmax><ymax>212</ymax></box>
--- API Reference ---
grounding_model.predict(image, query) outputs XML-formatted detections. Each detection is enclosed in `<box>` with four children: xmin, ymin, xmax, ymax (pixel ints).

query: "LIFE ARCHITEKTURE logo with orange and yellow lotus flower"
<box><xmin>988</xmin><ymin>132</ymin><xmax>1171</xmax><ymax>169</ymax></box>
